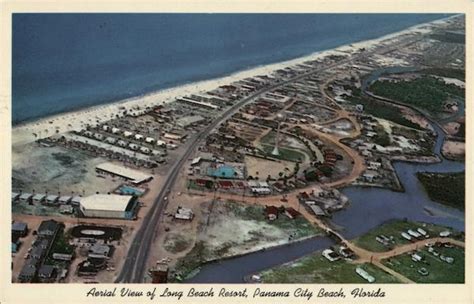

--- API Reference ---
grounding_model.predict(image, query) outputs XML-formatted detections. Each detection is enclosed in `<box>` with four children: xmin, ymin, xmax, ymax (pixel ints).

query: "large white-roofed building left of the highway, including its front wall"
<box><xmin>79</xmin><ymin>194</ymin><xmax>138</xmax><ymax>220</ymax></box>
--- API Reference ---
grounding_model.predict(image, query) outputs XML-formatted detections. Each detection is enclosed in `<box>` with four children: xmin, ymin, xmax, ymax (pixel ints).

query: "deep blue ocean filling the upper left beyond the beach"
<box><xmin>12</xmin><ymin>13</ymin><xmax>448</xmax><ymax>124</ymax></box>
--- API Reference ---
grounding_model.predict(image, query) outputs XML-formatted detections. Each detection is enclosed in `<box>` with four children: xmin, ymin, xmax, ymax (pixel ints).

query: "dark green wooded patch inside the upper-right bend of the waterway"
<box><xmin>370</xmin><ymin>76</ymin><xmax>464</xmax><ymax>116</ymax></box>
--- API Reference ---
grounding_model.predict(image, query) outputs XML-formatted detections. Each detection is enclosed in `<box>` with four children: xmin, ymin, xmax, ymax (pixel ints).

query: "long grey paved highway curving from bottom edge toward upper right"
<box><xmin>115</xmin><ymin>32</ymin><xmax>424</xmax><ymax>283</ymax></box>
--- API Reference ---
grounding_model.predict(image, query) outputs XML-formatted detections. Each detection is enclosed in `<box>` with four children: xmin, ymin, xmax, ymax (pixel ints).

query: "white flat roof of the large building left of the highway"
<box><xmin>80</xmin><ymin>194</ymin><xmax>133</xmax><ymax>211</ymax></box>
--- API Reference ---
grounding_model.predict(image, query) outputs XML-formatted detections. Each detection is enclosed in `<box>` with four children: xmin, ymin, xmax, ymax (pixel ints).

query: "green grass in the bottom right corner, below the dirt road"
<box><xmin>383</xmin><ymin>247</ymin><xmax>465</xmax><ymax>283</ymax></box>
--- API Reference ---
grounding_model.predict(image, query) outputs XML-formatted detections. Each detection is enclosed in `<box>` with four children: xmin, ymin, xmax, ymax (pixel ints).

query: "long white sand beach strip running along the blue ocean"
<box><xmin>12</xmin><ymin>15</ymin><xmax>459</xmax><ymax>146</ymax></box>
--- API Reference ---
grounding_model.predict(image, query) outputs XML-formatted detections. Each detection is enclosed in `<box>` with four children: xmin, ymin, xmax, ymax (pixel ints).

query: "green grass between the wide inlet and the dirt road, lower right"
<box><xmin>354</xmin><ymin>220</ymin><xmax>458</xmax><ymax>252</ymax></box>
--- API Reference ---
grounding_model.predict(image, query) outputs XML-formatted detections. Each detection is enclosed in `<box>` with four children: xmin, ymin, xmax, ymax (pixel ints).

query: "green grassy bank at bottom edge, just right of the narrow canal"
<box><xmin>261</xmin><ymin>252</ymin><xmax>399</xmax><ymax>283</ymax></box>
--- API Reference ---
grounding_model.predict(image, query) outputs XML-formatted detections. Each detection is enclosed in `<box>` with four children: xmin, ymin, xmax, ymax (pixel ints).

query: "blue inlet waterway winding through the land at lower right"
<box><xmin>186</xmin><ymin>73</ymin><xmax>465</xmax><ymax>283</ymax></box>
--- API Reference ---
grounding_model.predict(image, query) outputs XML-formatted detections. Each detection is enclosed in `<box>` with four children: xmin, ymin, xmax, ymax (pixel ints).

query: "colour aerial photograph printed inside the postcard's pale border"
<box><xmin>9</xmin><ymin>13</ymin><xmax>466</xmax><ymax>286</ymax></box>
